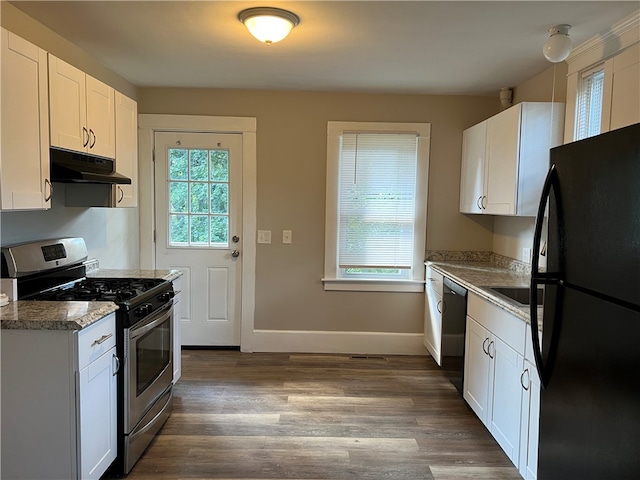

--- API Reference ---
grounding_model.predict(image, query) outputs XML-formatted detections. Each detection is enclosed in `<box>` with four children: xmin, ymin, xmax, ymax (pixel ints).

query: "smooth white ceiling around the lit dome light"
<box><xmin>11</xmin><ymin>0</ymin><xmax>640</xmax><ymax>95</ymax></box>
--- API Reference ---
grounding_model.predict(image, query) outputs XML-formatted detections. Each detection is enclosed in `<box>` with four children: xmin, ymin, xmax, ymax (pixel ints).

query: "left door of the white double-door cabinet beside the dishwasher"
<box><xmin>463</xmin><ymin>316</ymin><xmax>490</xmax><ymax>425</ymax></box>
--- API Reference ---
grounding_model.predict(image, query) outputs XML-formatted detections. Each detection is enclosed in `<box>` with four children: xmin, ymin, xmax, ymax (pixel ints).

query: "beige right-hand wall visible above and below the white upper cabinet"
<box><xmin>492</xmin><ymin>62</ymin><xmax>567</xmax><ymax>261</ymax></box>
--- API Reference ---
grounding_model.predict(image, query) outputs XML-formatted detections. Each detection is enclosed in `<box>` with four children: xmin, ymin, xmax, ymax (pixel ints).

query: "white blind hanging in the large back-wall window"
<box><xmin>337</xmin><ymin>133</ymin><xmax>418</xmax><ymax>270</ymax></box>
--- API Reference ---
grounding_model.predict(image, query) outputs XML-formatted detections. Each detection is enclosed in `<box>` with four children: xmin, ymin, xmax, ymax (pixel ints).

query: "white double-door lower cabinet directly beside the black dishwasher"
<box><xmin>463</xmin><ymin>293</ymin><xmax>526</xmax><ymax>466</ymax></box>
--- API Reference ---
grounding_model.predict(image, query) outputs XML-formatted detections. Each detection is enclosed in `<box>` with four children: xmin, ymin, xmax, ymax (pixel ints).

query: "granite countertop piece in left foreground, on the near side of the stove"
<box><xmin>0</xmin><ymin>300</ymin><xmax>118</xmax><ymax>330</ymax></box>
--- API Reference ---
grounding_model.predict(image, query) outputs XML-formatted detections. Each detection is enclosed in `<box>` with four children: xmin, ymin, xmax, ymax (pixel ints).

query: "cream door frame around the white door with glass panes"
<box><xmin>138</xmin><ymin>114</ymin><xmax>257</xmax><ymax>352</ymax></box>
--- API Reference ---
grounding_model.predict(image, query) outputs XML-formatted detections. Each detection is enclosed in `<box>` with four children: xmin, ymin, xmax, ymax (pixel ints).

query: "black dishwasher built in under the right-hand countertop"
<box><xmin>441</xmin><ymin>277</ymin><xmax>467</xmax><ymax>395</ymax></box>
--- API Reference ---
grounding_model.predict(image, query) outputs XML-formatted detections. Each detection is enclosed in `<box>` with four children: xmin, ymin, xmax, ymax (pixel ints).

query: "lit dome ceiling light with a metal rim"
<box><xmin>238</xmin><ymin>7</ymin><xmax>300</xmax><ymax>45</ymax></box>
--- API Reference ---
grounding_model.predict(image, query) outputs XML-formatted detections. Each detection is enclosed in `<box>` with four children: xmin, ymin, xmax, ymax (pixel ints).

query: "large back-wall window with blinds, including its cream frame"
<box><xmin>323</xmin><ymin>122</ymin><xmax>431</xmax><ymax>292</ymax></box>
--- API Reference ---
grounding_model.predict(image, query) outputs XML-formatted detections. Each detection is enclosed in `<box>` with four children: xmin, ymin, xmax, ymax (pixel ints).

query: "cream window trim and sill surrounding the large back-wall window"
<box><xmin>322</xmin><ymin>121</ymin><xmax>431</xmax><ymax>292</ymax></box>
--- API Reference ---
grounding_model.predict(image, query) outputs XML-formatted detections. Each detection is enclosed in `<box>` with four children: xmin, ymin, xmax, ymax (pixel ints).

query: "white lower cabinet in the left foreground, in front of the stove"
<box><xmin>1</xmin><ymin>314</ymin><xmax>119</xmax><ymax>480</ymax></box>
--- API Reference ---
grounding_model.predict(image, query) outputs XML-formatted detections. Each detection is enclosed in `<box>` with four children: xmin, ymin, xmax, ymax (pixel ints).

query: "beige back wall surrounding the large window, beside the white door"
<box><xmin>138</xmin><ymin>88</ymin><xmax>499</xmax><ymax>333</ymax></box>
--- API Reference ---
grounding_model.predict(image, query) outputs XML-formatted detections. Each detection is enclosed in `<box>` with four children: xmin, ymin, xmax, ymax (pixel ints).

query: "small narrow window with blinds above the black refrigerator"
<box><xmin>575</xmin><ymin>67</ymin><xmax>604</xmax><ymax>140</ymax></box>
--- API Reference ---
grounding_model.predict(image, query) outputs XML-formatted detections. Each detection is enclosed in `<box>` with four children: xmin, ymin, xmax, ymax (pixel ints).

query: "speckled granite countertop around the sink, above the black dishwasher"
<box><xmin>425</xmin><ymin>261</ymin><xmax>542</xmax><ymax>323</ymax></box>
